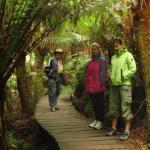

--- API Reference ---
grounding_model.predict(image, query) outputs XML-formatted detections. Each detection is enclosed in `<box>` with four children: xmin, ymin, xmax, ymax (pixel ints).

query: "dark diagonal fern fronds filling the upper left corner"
<box><xmin>0</xmin><ymin>0</ymin><xmax>86</xmax><ymax>82</ymax></box>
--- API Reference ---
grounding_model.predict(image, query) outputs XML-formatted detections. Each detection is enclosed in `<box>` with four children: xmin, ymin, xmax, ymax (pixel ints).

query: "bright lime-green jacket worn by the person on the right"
<box><xmin>110</xmin><ymin>49</ymin><xmax>136</xmax><ymax>85</ymax></box>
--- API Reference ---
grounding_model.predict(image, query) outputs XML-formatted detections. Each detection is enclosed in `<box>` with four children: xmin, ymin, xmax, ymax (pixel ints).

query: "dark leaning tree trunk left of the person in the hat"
<box><xmin>16</xmin><ymin>55</ymin><xmax>33</xmax><ymax>114</ymax></box>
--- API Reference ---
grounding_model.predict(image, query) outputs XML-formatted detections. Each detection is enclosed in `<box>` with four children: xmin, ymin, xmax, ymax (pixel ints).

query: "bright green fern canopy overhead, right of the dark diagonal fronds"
<box><xmin>46</xmin><ymin>0</ymin><xmax>132</xmax><ymax>49</ymax></box>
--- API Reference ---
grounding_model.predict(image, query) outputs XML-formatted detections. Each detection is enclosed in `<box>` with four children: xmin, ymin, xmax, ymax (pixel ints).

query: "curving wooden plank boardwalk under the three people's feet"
<box><xmin>35</xmin><ymin>96</ymin><xmax>137</xmax><ymax>150</ymax></box>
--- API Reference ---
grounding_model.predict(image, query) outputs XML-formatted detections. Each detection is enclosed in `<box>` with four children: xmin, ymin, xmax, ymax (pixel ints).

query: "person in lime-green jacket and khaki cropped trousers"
<box><xmin>106</xmin><ymin>38</ymin><xmax>136</xmax><ymax>140</ymax></box>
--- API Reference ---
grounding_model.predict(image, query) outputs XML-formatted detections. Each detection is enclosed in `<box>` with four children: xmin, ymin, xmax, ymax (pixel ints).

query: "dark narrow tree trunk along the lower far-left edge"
<box><xmin>0</xmin><ymin>80</ymin><xmax>8</xmax><ymax>150</ymax></box>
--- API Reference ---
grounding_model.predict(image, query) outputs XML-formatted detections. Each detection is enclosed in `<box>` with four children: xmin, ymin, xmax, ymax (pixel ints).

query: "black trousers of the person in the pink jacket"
<box><xmin>90</xmin><ymin>92</ymin><xmax>105</xmax><ymax>122</ymax></box>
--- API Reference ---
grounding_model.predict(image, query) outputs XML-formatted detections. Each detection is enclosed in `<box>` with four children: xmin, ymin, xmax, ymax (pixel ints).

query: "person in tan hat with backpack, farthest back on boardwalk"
<box><xmin>44</xmin><ymin>48</ymin><xmax>63</xmax><ymax>112</ymax></box>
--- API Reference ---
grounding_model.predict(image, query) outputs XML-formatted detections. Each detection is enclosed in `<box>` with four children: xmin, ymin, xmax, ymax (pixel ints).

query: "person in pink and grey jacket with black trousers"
<box><xmin>84</xmin><ymin>43</ymin><xmax>107</xmax><ymax>129</ymax></box>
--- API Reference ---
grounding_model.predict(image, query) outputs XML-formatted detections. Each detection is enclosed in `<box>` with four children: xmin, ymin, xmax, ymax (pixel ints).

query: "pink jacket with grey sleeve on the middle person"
<box><xmin>84</xmin><ymin>57</ymin><xmax>108</xmax><ymax>93</ymax></box>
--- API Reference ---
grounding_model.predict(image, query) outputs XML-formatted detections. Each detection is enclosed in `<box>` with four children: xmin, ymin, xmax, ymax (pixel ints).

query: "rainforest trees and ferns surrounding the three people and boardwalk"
<box><xmin>0</xmin><ymin>0</ymin><xmax>150</xmax><ymax>150</ymax></box>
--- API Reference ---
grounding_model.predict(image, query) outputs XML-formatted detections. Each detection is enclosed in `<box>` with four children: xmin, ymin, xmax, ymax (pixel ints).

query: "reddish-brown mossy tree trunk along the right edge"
<box><xmin>134</xmin><ymin>0</ymin><xmax>150</xmax><ymax>143</ymax></box>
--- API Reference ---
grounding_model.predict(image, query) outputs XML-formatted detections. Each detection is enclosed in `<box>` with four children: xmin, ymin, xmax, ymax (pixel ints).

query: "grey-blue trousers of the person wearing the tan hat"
<box><xmin>48</xmin><ymin>79</ymin><xmax>61</xmax><ymax>107</ymax></box>
